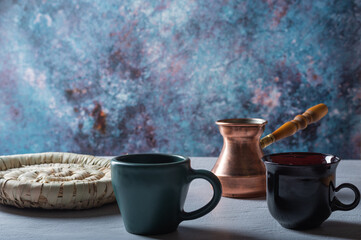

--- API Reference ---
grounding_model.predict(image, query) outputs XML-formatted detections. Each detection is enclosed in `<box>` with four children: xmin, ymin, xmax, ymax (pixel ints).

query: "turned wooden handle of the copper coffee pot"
<box><xmin>260</xmin><ymin>103</ymin><xmax>328</xmax><ymax>148</ymax></box>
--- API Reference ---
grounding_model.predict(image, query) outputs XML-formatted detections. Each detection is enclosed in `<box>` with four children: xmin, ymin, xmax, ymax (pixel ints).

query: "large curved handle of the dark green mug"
<box><xmin>181</xmin><ymin>169</ymin><xmax>222</xmax><ymax>221</ymax></box>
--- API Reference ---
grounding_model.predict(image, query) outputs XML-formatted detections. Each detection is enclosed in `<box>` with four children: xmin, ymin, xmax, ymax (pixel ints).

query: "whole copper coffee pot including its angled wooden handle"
<box><xmin>212</xmin><ymin>103</ymin><xmax>328</xmax><ymax>198</ymax></box>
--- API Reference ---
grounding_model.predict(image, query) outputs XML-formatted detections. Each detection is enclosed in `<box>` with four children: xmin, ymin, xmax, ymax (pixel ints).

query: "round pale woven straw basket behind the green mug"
<box><xmin>0</xmin><ymin>152</ymin><xmax>115</xmax><ymax>209</ymax></box>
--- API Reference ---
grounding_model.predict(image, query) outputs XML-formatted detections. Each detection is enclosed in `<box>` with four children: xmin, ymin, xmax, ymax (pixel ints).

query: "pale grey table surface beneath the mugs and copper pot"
<box><xmin>0</xmin><ymin>157</ymin><xmax>361</xmax><ymax>240</ymax></box>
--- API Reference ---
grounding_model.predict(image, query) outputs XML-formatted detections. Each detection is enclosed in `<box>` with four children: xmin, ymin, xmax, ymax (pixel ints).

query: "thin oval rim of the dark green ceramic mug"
<box><xmin>111</xmin><ymin>153</ymin><xmax>190</xmax><ymax>167</ymax></box>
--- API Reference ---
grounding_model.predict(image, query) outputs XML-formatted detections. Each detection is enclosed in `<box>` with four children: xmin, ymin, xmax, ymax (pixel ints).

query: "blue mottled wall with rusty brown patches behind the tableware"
<box><xmin>0</xmin><ymin>0</ymin><xmax>361</xmax><ymax>158</ymax></box>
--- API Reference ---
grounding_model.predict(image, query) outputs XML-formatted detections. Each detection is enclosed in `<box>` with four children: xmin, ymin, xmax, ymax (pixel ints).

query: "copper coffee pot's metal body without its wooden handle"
<box><xmin>212</xmin><ymin>118</ymin><xmax>267</xmax><ymax>198</ymax></box>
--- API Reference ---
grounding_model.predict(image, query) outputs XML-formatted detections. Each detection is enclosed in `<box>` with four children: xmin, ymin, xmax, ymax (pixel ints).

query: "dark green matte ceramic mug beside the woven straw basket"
<box><xmin>111</xmin><ymin>153</ymin><xmax>222</xmax><ymax>235</ymax></box>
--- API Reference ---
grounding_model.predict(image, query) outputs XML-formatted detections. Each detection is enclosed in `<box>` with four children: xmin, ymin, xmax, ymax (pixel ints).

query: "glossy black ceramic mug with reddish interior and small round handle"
<box><xmin>262</xmin><ymin>152</ymin><xmax>360</xmax><ymax>229</ymax></box>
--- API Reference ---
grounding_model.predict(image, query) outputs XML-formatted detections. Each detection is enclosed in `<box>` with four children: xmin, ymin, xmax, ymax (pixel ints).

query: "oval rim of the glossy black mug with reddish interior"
<box><xmin>262</xmin><ymin>152</ymin><xmax>341</xmax><ymax>168</ymax></box>
